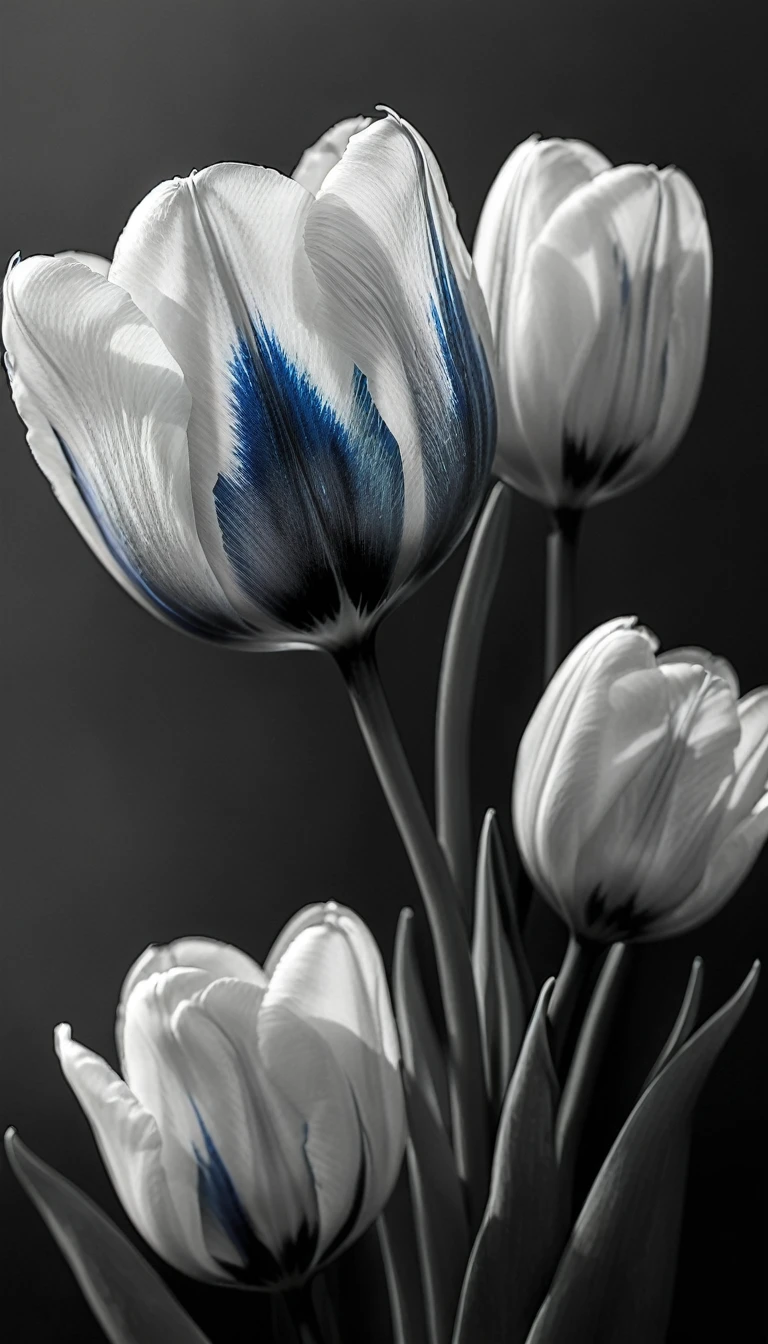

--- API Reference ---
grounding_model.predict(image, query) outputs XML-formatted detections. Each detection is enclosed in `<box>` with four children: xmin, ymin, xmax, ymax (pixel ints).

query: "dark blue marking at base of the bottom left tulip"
<box><xmin>192</xmin><ymin>1102</ymin><xmax>319</xmax><ymax>1288</ymax></box>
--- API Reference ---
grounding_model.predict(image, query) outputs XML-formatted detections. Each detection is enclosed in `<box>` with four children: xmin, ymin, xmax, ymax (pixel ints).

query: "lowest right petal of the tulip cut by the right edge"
<box><xmin>646</xmin><ymin>796</ymin><xmax>768</xmax><ymax>941</ymax></box>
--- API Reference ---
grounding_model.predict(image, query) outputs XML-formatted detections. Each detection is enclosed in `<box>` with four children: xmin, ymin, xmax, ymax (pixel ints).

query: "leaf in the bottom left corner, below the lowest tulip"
<box><xmin>5</xmin><ymin>1129</ymin><xmax>210</xmax><ymax>1344</ymax></box>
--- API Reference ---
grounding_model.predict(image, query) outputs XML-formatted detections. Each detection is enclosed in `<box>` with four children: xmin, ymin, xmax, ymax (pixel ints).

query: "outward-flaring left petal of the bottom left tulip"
<box><xmin>55</xmin><ymin>1025</ymin><xmax>216</xmax><ymax>1279</ymax></box>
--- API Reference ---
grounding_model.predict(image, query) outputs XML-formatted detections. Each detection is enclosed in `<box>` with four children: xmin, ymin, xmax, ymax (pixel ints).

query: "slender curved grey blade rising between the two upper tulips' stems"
<box><xmin>434</xmin><ymin>481</ymin><xmax>512</xmax><ymax>925</ymax></box>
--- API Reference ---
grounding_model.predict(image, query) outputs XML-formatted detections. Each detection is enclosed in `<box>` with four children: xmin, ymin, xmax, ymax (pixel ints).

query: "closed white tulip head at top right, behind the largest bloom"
<box><xmin>473</xmin><ymin>137</ymin><xmax>712</xmax><ymax>509</ymax></box>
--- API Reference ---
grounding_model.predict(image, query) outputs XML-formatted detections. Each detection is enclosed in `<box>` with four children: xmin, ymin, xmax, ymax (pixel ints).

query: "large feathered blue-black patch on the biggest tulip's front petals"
<box><xmin>214</xmin><ymin>323</ymin><xmax>404</xmax><ymax>633</ymax></box>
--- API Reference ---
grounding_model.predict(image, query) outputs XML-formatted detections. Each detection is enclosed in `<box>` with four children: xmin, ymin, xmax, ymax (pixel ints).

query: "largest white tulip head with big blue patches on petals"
<box><xmin>3</xmin><ymin>116</ymin><xmax>495</xmax><ymax>648</ymax></box>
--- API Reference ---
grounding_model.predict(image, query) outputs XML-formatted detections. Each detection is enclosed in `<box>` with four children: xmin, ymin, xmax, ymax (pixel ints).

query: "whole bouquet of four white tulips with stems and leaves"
<box><xmin>3</xmin><ymin>113</ymin><xmax>768</xmax><ymax>1344</ymax></box>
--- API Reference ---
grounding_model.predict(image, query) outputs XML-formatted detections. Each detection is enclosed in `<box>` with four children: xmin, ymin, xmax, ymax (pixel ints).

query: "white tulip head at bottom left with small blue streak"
<box><xmin>56</xmin><ymin>903</ymin><xmax>405</xmax><ymax>1289</ymax></box>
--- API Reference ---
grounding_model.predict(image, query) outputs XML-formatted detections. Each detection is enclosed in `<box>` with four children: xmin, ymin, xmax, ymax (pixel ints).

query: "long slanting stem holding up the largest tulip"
<box><xmin>336</xmin><ymin>638</ymin><xmax>490</xmax><ymax>1230</ymax></box>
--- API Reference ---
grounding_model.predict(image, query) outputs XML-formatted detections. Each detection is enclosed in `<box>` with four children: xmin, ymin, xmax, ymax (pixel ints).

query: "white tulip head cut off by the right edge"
<box><xmin>512</xmin><ymin>617</ymin><xmax>768</xmax><ymax>942</ymax></box>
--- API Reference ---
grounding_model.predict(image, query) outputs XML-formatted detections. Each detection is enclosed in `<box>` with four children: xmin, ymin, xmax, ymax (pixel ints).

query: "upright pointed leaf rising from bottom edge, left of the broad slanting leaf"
<box><xmin>453</xmin><ymin>980</ymin><xmax>567</xmax><ymax>1344</ymax></box>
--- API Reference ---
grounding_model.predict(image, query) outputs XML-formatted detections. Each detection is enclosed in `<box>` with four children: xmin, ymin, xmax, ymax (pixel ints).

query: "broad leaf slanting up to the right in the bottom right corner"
<box><xmin>527</xmin><ymin>965</ymin><xmax>759</xmax><ymax>1344</ymax></box>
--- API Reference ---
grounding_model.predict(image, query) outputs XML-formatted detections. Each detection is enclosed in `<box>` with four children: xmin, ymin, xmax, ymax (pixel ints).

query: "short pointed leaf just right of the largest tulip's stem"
<box><xmin>472</xmin><ymin>808</ymin><xmax>534</xmax><ymax>1121</ymax></box>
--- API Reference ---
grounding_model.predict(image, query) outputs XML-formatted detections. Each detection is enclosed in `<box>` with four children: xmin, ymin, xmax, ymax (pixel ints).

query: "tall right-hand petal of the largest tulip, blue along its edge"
<box><xmin>304</xmin><ymin>116</ymin><xmax>495</xmax><ymax>578</ymax></box>
